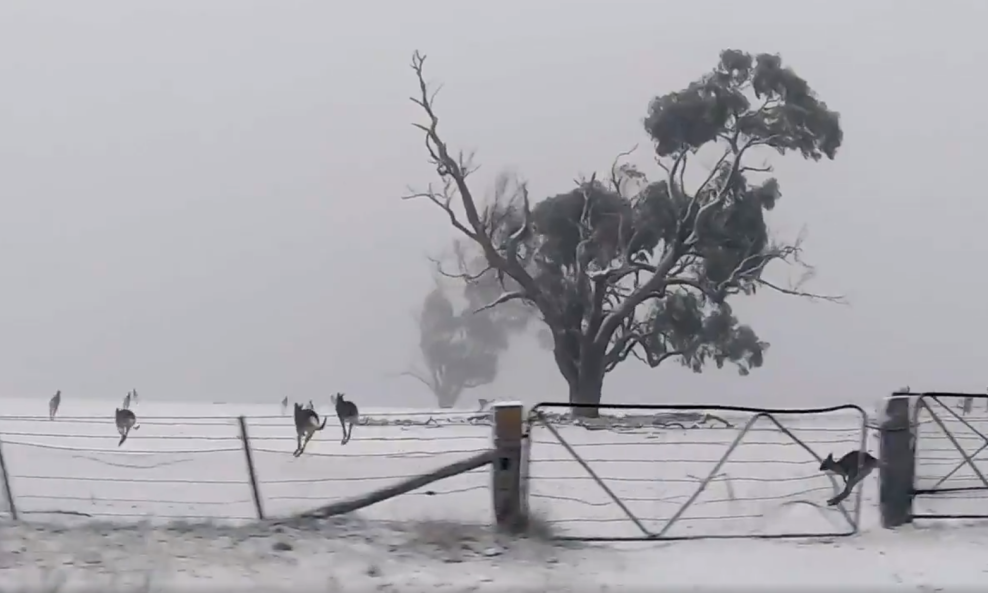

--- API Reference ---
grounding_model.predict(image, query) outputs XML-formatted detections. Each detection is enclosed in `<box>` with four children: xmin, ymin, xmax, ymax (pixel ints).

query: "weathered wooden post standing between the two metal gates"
<box><xmin>878</xmin><ymin>394</ymin><xmax>916</xmax><ymax>529</ymax></box>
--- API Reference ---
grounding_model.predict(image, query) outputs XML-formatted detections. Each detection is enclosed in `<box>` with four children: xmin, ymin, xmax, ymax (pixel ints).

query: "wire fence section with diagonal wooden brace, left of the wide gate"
<box><xmin>0</xmin><ymin>413</ymin><xmax>502</xmax><ymax>521</ymax></box>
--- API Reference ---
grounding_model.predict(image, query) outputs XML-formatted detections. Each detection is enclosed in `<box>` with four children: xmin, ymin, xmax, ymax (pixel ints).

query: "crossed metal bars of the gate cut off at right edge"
<box><xmin>912</xmin><ymin>392</ymin><xmax>988</xmax><ymax>519</ymax></box>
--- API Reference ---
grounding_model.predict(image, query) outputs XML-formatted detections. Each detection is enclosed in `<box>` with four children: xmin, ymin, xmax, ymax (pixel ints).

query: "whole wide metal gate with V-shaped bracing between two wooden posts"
<box><xmin>525</xmin><ymin>402</ymin><xmax>868</xmax><ymax>541</ymax></box>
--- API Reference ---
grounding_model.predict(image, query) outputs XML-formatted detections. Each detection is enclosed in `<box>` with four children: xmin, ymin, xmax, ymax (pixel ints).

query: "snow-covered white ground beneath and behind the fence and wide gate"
<box><xmin>0</xmin><ymin>398</ymin><xmax>988</xmax><ymax>592</ymax></box>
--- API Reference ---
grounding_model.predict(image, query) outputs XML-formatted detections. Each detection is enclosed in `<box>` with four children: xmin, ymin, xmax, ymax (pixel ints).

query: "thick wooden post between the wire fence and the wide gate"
<box><xmin>491</xmin><ymin>402</ymin><xmax>528</xmax><ymax>532</ymax></box>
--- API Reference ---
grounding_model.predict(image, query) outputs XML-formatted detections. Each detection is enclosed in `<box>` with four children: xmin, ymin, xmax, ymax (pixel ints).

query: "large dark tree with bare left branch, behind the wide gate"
<box><xmin>409</xmin><ymin>50</ymin><xmax>843</xmax><ymax>415</ymax></box>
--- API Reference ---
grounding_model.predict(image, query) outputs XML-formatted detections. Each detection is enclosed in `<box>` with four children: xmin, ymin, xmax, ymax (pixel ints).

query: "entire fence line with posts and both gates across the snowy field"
<box><xmin>7</xmin><ymin>393</ymin><xmax>988</xmax><ymax>541</ymax></box>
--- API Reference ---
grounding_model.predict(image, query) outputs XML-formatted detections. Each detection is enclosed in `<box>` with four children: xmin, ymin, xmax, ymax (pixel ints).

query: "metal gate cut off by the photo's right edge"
<box><xmin>912</xmin><ymin>392</ymin><xmax>988</xmax><ymax>519</ymax></box>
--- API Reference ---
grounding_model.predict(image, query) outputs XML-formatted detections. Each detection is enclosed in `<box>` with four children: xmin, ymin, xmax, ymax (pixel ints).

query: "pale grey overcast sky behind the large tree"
<box><xmin>0</xmin><ymin>0</ymin><xmax>988</xmax><ymax>406</ymax></box>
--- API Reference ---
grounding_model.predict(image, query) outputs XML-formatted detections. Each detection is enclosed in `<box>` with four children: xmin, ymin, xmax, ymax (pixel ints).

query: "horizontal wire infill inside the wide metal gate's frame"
<box><xmin>528</xmin><ymin>404</ymin><xmax>867</xmax><ymax>539</ymax></box>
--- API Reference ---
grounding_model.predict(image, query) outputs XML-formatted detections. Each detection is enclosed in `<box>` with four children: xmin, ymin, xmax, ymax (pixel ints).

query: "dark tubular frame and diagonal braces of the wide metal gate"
<box><xmin>526</xmin><ymin>396</ymin><xmax>868</xmax><ymax>542</ymax></box>
